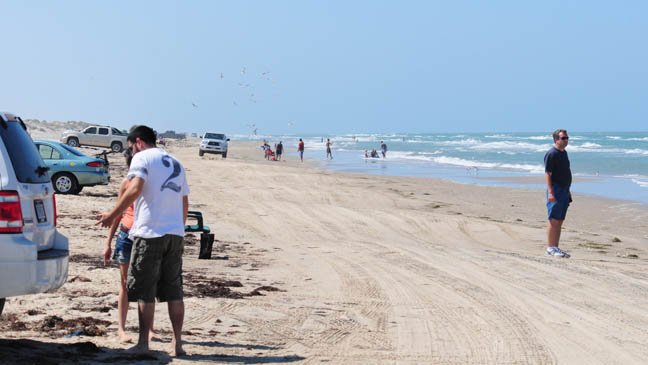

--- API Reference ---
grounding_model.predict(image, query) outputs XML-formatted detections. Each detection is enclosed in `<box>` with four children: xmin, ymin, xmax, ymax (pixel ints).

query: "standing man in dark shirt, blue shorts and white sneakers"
<box><xmin>544</xmin><ymin>129</ymin><xmax>572</xmax><ymax>258</ymax></box>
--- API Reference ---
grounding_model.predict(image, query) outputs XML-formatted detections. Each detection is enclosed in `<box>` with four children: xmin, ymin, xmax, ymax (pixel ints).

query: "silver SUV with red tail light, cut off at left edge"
<box><xmin>0</xmin><ymin>112</ymin><xmax>69</xmax><ymax>313</ymax></box>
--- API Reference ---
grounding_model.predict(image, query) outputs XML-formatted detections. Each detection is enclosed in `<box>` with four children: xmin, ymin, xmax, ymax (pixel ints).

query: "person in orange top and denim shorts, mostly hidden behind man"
<box><xmin>104</xmin><ymin>149</ymin><xmax>153</xmax><ymax>343</ymax></box>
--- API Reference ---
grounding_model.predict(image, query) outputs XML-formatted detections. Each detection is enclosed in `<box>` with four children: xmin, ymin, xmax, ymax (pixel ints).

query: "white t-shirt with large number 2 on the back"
<box><xmin>127</xmin><ymin>148</ymin><xmax>189</xmax><ymax>239</ymax></box>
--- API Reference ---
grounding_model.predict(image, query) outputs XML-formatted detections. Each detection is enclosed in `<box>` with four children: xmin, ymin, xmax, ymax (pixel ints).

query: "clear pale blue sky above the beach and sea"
<box><xmin>0</xmin><ymin>1</ymin><xmax>648</xmax><ymax>134</ymax></box>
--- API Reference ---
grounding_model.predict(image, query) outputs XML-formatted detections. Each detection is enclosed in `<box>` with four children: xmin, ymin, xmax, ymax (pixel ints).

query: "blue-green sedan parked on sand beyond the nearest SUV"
<box><xmin>34</xmin><ymin>140</ymin><xmax>110</xmax><ymax>194</ymax></box>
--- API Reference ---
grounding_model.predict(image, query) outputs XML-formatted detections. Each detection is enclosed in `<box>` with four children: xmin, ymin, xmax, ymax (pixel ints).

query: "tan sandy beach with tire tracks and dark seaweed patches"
<box><xmin>0</xmin><ymin>139</ymin><xmax>648</xmax><ymax>364</ymax></box>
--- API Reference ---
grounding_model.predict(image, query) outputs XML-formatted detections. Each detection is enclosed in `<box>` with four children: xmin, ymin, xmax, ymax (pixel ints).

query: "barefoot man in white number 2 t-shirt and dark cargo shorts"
<box><xmin>96</xmin><ymin>126</ymin><xmax>189</xmax><ymax>356</ymax></box>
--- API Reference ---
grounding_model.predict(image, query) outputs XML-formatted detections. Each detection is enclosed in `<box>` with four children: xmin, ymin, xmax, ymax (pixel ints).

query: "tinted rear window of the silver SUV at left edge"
<box><xmin>0</xmin><ymin>121</ymin><xmax>49</xmax><ymax>183</ymax></box>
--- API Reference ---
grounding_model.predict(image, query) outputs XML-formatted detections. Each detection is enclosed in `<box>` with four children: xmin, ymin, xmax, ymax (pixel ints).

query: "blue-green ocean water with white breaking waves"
<box><xmin>233</xmin><ymin>132</ymin><xmax>648</xmax><ymax>203</ymax></box>
